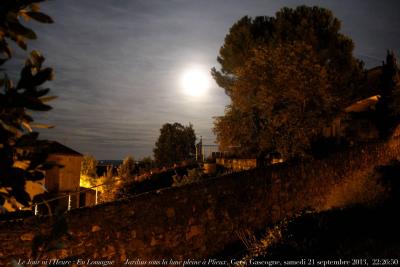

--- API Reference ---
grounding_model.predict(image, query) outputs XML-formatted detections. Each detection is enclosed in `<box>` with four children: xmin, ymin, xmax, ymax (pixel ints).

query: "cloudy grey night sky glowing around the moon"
<box><xmin>17</xmin><ymin>0</ymin><xmax>400</xmax><ymax>159</ymax></box>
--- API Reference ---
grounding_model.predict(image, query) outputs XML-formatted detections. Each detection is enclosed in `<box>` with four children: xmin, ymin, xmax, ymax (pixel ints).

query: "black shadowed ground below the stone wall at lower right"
<box><xmin>241</xmin><ymin>161</ymin><xmax>400</xmax><ymax>264</ymax></box>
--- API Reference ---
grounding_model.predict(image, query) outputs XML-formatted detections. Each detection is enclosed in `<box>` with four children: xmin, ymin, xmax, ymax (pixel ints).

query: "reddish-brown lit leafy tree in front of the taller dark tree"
<box><xmin>214</xmin><ymin>43</ymin><xmax>333</xmax><ymax>157</ymax></box>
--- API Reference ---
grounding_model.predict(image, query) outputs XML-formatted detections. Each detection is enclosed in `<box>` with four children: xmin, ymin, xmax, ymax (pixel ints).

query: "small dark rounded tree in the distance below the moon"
<box><xmin>154</xmin><ymin>122</ymin><xmax>196</xmax><ymax>166</ymax></box>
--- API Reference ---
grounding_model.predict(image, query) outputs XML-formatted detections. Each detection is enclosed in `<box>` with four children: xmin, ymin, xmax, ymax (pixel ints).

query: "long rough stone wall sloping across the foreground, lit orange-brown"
<box><xmin>0</xmin><ymin>140</ymin><xmax>399</xmax><ymax>266</ymax></box>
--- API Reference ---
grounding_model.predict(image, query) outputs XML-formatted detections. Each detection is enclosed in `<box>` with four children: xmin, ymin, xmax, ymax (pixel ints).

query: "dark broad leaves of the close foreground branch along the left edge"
<box><xmin>0</xmin><ymin>0</ymin><xmax>54</xmax><ymax>209</ymax></box>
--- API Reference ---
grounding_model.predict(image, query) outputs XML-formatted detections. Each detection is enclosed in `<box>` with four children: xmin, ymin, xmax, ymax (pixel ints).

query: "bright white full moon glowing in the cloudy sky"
<box><xmin>181</xmin><ymin>68</ymin><xmax>211</xmax><ymax>98</ymax></box>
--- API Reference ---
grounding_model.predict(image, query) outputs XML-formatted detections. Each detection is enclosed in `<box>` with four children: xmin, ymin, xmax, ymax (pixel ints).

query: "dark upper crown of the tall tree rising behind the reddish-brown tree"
<box><xmin>212</xmin><ymin>6</ymin><xmax>363</xmax><ymax>104</ymax></box>
